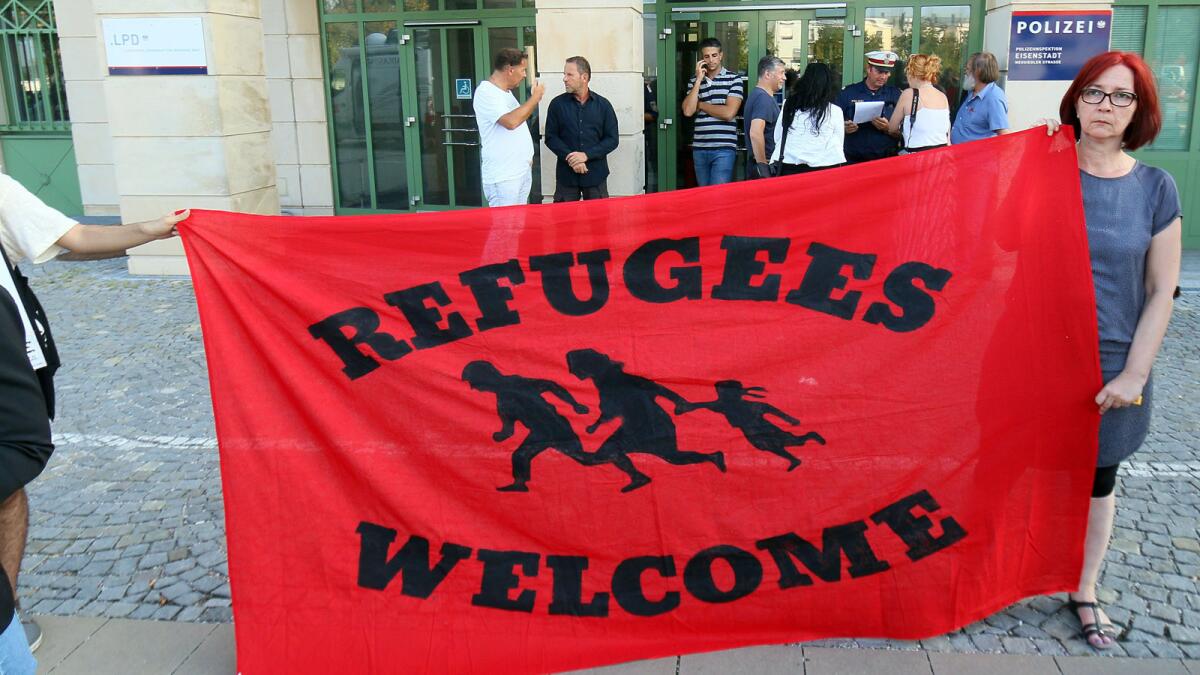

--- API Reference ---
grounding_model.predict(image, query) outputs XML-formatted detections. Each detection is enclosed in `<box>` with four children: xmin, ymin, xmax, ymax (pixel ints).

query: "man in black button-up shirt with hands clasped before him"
<box><xmin>546</xmin><ymin>56</ymin><xmax>617</xmax><ymax>202</ymax></box>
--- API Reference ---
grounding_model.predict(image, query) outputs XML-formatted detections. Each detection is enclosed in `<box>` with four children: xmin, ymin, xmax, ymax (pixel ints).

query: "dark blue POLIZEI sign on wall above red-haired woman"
<box><xmin>1008</xmin><ymin>10</ymin><xmax>1112</xmax><ymax>80</ymax></box>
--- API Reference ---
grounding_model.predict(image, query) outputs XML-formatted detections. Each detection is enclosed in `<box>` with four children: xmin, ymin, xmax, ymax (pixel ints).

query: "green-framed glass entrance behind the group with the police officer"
<box><xmin>647</xmin><ymin>0</ymin><xmax>984</xmax><ymax>190</ymax></box>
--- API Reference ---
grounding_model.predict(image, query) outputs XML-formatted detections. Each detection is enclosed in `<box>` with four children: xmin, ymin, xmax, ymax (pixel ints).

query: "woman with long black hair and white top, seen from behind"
<box><xmin>770</xmin><ymin>64</ymin><xmax>846</xmax><ymax>175</ymax></box>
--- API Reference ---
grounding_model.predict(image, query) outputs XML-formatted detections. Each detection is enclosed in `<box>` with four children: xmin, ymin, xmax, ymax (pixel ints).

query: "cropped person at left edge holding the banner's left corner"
<box><xmin>0</xmin><ymin>173</ymin><xmax>190</xmax><ymax>649</ymax></box>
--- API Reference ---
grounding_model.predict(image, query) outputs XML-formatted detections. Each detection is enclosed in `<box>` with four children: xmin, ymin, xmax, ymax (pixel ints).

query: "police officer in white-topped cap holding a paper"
<box><xmin>838</xmin><ymin>52</ymin><xmax>900</xmax><ymax>165</ymax></box>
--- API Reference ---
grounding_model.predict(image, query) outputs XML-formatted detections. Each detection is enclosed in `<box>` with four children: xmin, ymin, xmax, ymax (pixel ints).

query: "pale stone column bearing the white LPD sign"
<box><xmin>93</xmin><ymin>0</ymin><xmax>280</xmax><ymax>274</ymax></box>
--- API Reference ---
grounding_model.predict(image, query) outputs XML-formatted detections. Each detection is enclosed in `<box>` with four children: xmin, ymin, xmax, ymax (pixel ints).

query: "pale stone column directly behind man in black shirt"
<box><xmin>538</xmin><ymin>0</ymin><xmax>646</xmax><ymax>201</ymax></box>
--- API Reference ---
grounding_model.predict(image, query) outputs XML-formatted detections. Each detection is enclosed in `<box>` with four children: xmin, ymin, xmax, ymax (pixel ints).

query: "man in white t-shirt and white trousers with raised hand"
<box><xmin>473</xmin><ymin>48</ymin><xmax>546</xmax><ymax>207</ymax></box>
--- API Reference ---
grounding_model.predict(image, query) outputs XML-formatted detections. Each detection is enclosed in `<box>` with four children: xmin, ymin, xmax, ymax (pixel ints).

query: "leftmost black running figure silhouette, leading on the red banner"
<box><xmin>462</xmin><ymin>360</ymin><xmax>604</xmax><ymax>492</ymax></box>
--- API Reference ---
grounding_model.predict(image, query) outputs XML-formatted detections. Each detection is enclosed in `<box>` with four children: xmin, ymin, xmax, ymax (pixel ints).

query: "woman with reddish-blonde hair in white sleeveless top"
<box><xmin>888</xmin><ymin>54</ymin><xmax>950</xmax><ymax>153</ymax></box>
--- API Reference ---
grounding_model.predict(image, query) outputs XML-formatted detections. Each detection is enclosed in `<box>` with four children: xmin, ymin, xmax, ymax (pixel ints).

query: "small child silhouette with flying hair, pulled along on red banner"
<box><xmin>680</xmin><ymin>380</ymin><xmax>824</xmax><ymax>471</ymax></box>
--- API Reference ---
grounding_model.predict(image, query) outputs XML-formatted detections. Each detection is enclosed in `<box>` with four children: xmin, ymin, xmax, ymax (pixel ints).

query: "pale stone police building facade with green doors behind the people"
<box><xmin>0</xmin><ymin>0</ymin><xmax>1200</xmax><ymax>274</ymax></box>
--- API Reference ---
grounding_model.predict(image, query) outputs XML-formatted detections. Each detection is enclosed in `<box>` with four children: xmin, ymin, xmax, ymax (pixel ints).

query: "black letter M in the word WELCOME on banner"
<box><xmin>755</xmin><ymin>520</ymin><xmax>890</xmax><ymax>589</ymax></box>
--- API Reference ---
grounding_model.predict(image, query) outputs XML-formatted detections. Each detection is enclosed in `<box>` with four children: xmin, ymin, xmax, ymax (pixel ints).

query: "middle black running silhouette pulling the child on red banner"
<box><xmin>566</xmin><ymin>350</ymin><xmax>725</xmax><ymax>492</ymax></box>
